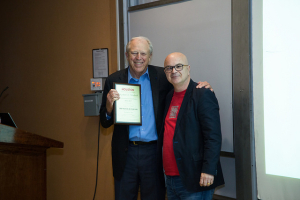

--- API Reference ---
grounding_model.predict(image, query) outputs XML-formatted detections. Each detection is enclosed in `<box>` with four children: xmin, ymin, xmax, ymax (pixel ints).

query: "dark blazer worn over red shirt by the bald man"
<box><xmin>158</xmin><ymin>80</ymin><xmax>224</xmax><ymax>192</ymax></box>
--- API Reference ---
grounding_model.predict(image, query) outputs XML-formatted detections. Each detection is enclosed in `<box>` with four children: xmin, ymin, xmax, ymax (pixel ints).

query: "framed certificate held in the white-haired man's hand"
<box><xmin>114</xmin><ymin>83</ymin><xmax>142</xmax><ymax>125</ymax></box>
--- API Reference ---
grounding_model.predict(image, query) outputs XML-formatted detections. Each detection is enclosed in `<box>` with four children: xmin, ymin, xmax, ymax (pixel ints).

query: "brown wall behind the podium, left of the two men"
<box><xmin>0</xmin><ymin>0</ymin><xmax>117</xmax><ymax>200</ymax></box>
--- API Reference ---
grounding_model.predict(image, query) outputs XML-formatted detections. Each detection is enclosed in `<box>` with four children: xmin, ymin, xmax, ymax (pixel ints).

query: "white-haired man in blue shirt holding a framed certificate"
<box><xmin>100</xmin><ymin>37</ymin><xmax>210</xmax><ymax>200</ymax></box>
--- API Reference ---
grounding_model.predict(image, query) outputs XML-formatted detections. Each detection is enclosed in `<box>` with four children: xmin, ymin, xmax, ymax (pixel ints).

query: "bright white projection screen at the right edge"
<box><xmin>252</xmin><ymin>0</ymin><xmax>300</xmax><ymax>200</ymax></box>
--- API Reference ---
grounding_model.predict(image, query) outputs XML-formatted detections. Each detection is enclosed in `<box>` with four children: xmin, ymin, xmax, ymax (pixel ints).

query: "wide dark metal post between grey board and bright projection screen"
<box><xmin>231</xmin><ymin>0</ymin><xmax>257</xmax><ymax>200</ymax></box>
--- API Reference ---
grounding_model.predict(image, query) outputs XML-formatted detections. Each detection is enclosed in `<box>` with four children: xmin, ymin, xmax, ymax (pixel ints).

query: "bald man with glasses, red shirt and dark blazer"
<box><xmin>158</xmin><ymin>52</ymin><xmax>224</xmax><ymax>200</ymax></box>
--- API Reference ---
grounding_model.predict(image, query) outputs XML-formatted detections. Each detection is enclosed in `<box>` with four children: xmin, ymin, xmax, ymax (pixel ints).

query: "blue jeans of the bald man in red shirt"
<box><xmin>166</xmin><ymin>176</ymin><xmax>215</xmax><ymax>200</ymax></box>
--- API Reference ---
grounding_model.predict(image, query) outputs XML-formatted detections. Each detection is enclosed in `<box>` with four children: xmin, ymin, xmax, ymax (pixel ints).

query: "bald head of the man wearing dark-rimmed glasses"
<box><xmin>164</xmin><ymin>52</ymin><xmax>190</xmax><ymax>92</ymax></box>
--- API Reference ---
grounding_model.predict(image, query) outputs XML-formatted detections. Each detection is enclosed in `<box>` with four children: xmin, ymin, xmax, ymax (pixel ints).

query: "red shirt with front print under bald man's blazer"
<box><xmin>163</xmin><ymin>90</ymin><xmax>186</xmax><ymax>176</ymax></box>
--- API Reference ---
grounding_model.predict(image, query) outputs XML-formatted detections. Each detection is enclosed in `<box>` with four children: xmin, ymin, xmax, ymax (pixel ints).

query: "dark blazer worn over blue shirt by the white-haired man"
<box><xmin>100</xmin><ymin>65</ymin><xmax>173</xmax><ymax>180</ymax></box>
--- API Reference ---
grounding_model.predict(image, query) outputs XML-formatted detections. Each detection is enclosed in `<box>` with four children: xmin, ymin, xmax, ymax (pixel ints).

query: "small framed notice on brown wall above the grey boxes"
<box><xmin>92</xmin><ymin>48</ymin><xmax>109</xmax><ymax>78</ymax></box>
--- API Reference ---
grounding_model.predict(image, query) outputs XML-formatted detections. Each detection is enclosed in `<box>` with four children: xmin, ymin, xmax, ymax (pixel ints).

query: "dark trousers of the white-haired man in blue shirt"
<box><xmin>115</xmin><ymin>144</ymin><xmax>165</xmax><ymax>200</ymax></box>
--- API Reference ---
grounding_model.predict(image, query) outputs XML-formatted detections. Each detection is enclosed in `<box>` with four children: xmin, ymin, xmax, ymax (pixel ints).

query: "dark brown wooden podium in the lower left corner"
<box><xmin>0</xmin><ymin>124</ymin><xmax>64</xmax><ymax>200</ymax></box>
